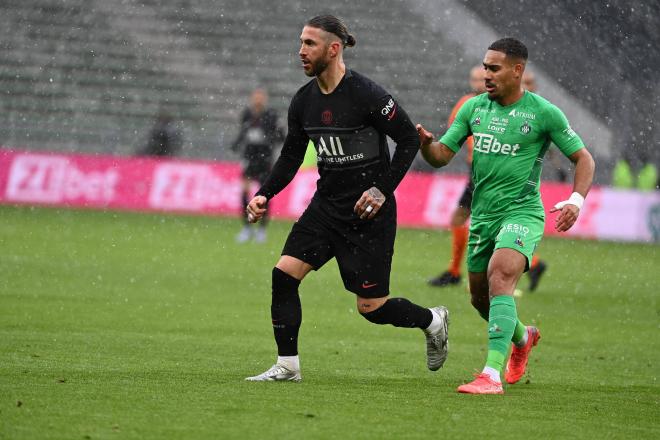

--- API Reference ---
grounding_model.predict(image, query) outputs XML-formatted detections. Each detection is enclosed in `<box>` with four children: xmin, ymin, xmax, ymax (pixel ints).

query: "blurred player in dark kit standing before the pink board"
<box><xmin>232</xmin><ymin>88</ymin><xmax>284</xmax><ymax>243</ymax></box>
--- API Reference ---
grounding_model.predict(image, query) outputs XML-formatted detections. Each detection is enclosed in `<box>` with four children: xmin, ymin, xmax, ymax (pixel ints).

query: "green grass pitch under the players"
<box><xmin>0</xmin><ymin>207</ymin><xmax>660</xmax><ymax>439</ymax></box>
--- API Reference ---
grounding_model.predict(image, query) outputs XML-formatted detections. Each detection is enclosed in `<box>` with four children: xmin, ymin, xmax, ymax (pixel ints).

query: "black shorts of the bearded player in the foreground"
<box><xmin>282</xmin><ymin>199</ymin><xmax>396</xmax><ymax>298</ymax></box>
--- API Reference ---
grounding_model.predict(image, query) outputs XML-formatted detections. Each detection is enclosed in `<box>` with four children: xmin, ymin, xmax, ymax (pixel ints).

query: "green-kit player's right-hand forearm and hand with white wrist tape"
<box><xmin>550</xmin><ymin>148</ymin><xmax>596</xmax><ymax>232</ymax></box>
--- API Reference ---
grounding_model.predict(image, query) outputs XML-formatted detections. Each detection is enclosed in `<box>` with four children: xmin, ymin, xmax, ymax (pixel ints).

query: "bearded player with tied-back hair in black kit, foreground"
<box><xmin>246</xmin><ymin>15</ymin><xmax>448</xmax><ymax>381</ymax></box>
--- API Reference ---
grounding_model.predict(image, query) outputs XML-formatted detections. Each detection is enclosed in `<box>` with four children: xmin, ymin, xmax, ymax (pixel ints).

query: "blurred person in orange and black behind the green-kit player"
<box><xmin>429</xmin><ymin>66</ymin><xmax>558</xmax><ymax>291</ymax></box>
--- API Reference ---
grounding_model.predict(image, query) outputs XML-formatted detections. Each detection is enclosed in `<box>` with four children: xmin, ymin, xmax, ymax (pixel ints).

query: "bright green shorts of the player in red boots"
<box><xmin>467</xmin><ymin>210</ymin><xmax>545</xmax><ymax>272</ymax></box>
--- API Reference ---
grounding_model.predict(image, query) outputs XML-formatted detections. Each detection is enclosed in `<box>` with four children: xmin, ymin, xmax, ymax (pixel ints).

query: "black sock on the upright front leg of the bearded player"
<box><xmin>270</xmin><ymin>267</ymin><xmax>302</xmax><ymax>356</ymax></box>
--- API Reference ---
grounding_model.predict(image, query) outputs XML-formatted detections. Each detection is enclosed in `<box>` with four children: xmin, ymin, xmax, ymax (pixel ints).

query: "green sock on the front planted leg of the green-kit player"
<box><xmin>486</xmin><ymin>295</ymin><xmax>518</xmax><ymax>371</ymax></box>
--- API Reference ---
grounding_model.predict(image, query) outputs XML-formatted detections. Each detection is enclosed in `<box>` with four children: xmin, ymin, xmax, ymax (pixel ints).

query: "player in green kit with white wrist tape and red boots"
<box><xmin>417</xmin><ymin>38</ymin><xmax>594</xmax><ymax>394</ymax></box>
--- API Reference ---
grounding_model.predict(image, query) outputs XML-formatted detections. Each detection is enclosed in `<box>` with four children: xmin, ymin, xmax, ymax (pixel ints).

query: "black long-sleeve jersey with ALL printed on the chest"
<box><xmin>257</xmin><ymin>69</ymin><xmax>419</xmax><ymax>225</ymax></box>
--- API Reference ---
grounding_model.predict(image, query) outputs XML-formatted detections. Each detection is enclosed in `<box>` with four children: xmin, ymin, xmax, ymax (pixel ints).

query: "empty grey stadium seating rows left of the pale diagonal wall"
<box><xmin>0</xmin><ymin>0</ymin><xmax>466</xmax><ymax>159</ymax></box>
